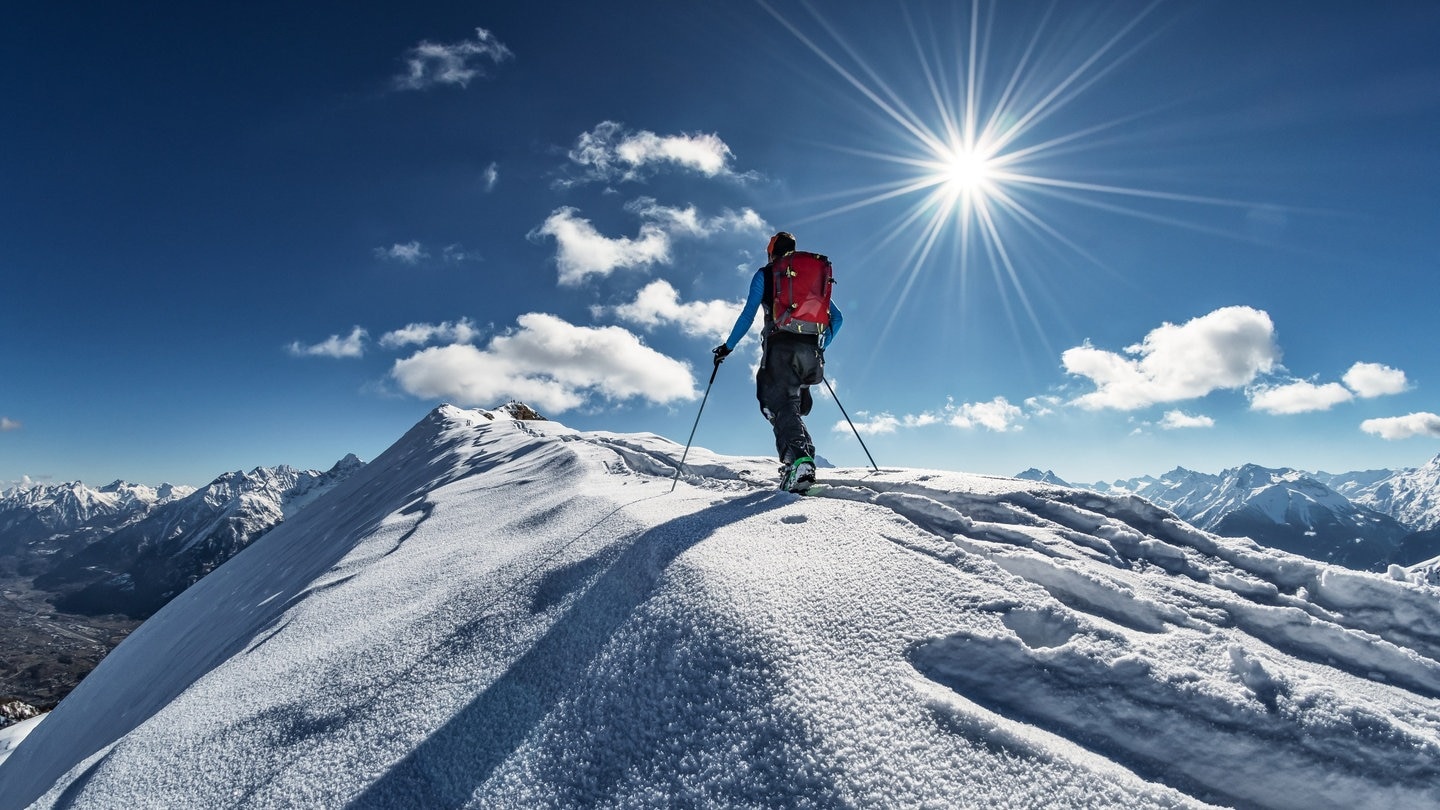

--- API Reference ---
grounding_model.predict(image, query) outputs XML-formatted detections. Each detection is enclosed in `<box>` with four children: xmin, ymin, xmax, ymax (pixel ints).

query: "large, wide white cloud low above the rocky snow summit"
<box><xmin>390</xmin><ymin>313</ymin><xmax>698</xmax><ymax>412</ymax></box>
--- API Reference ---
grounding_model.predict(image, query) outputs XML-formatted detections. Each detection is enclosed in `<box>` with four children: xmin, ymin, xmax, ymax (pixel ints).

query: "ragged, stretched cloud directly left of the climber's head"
<box><xmin>530</xmin><ymin>197</ymin><xmax>765</xmax><ymax>285</ymax></box>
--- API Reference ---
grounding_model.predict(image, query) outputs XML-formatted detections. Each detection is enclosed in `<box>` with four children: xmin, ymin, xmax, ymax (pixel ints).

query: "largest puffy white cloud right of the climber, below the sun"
<box><xmin>1061</xmin><ymin>307</ymin><xmax>1280</xmax><ymax>411</ymax></box>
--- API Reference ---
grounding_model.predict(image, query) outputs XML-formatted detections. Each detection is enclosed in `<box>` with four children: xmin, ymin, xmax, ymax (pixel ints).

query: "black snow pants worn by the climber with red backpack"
<box><xmin>755</xmin><ymin>331</ymin><xmax>825</xmax><ymax>464</ymax></box>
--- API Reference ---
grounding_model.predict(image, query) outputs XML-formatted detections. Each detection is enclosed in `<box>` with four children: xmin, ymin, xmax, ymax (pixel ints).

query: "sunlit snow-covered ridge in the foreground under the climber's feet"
<box><xmin>0</xmin><ymin>406</ymin><xmax>1440</xmax><ymax>809</ymax></box>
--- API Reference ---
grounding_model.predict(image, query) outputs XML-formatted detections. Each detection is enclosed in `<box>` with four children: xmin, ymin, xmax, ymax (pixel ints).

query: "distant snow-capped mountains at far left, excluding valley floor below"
<box><xmin>0</xmin><ymin>455</ymin><xmax>363</xmax><ymax>618</ymax></box>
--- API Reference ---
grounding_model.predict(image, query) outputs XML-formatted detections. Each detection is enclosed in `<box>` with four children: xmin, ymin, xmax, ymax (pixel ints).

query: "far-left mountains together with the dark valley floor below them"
<box><xmin>0</xmin><ymin>457</ymin><xmax>360</xmax><ymax>714</ymax></box>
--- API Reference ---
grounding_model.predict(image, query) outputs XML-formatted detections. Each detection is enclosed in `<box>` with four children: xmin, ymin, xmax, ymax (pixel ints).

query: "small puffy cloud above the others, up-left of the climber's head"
<box><xmin>562</xmin><ymin>121</ymin><xmax>736</xmax><ymax>184</ymax></box>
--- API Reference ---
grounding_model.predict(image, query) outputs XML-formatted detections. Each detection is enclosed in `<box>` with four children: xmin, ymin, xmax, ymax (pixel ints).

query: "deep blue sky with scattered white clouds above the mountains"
<box><xmin>0</xmin><ymin>0</ymin><xmax>1440</xmax><ymax>486</ymax></box>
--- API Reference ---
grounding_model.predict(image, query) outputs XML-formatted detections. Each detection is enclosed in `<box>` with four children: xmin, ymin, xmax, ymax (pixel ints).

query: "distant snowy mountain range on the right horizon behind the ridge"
<box><xmin>1017</xmin><ymin>455</ymin><xmax>1440</xmax><ymax>571</ymax></box>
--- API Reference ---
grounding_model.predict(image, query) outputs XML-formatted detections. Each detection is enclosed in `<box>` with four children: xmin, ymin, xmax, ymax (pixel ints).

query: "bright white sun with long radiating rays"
<box><xmin>757</xmin><ymin>0</ymin><xmax>1251</xmax><ymax>355</ymax></box>
